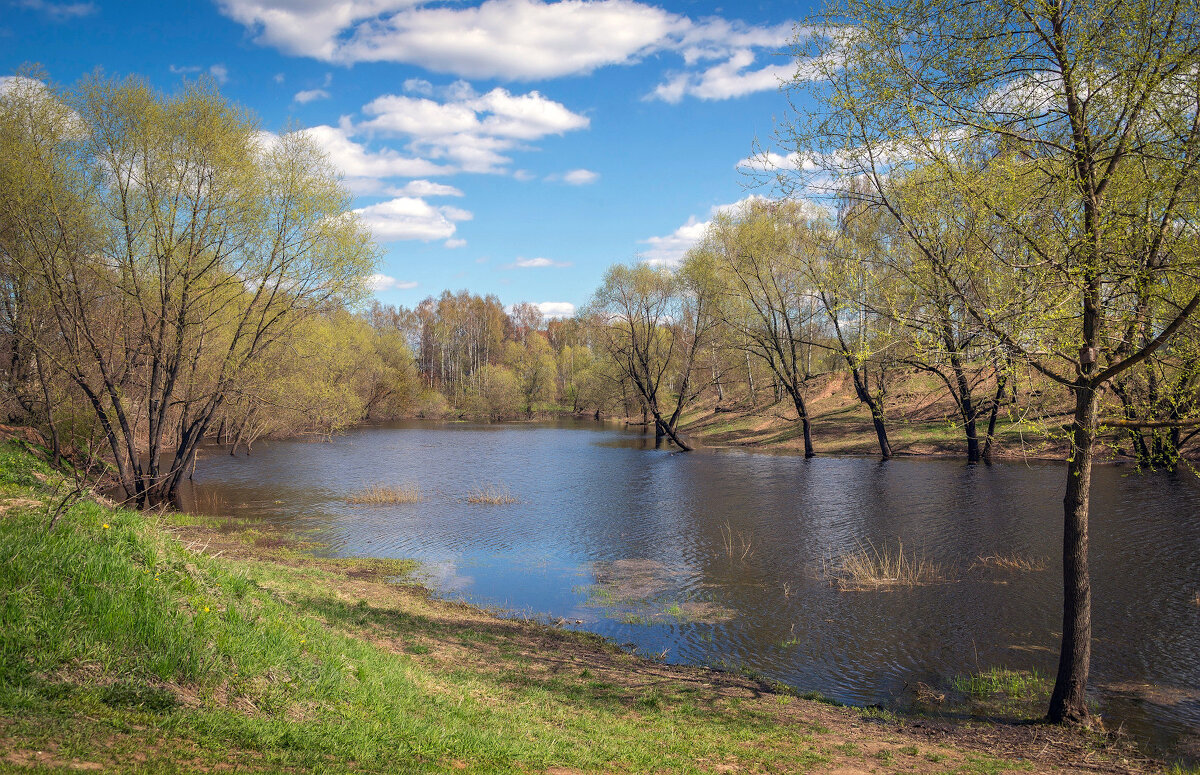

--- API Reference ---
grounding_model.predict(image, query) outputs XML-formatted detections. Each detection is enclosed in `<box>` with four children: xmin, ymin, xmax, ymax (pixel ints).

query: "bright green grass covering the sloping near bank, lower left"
<box><xmin>0</xmin><ymin>444</ymin><xmax>844</xmax><ymax>773</ymax></box>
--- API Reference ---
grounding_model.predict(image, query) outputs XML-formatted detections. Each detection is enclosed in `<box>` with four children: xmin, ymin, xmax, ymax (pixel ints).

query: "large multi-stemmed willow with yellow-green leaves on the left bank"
<box><xmin>0</xmin><ymin>77</ymin><xmax>374</xmax><ymax>505</ymax></box>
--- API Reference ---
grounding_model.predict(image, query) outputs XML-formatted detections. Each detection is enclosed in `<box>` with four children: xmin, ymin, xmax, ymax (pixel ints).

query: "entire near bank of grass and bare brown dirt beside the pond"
<box><xmin>0</xmin><ymin>441</ymin><xmax>1156</xmax><ymax>774</ymax></box>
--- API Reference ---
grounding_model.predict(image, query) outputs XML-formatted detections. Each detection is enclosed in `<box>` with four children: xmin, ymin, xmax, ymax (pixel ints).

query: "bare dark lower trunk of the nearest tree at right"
<box><xmin>1046</xmin><ymin>383</ymin><xmax>1097</xmax><ymax>723</ymax></box>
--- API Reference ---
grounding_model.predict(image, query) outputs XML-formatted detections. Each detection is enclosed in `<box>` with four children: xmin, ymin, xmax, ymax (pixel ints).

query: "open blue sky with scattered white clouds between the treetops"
<box><xmin>0</xmin><ymin>0</ymin><xmax>810</xmax><ymax>314</ymax></box>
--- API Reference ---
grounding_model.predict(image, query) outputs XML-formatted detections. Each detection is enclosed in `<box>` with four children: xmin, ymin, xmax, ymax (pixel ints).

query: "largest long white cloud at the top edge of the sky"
<box><xmin>218</xmin><ymin>0</ymin><xmax>796</xmax><ymax>102</ymax></box>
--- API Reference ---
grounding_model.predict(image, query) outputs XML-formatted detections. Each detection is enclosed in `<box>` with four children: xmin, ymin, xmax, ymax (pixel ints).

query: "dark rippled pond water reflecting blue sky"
<box><xmin>185</xmin><ymin>423</ymin><xmax>1200</xmax><ymax>755</ymax></box>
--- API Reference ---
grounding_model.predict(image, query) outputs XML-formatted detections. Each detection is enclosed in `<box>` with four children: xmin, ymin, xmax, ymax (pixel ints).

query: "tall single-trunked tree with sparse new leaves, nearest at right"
<box><xmin>778</xmin><ymin>0</ymin><xmax>1200</xmax><ymax>722</ymax></box>
